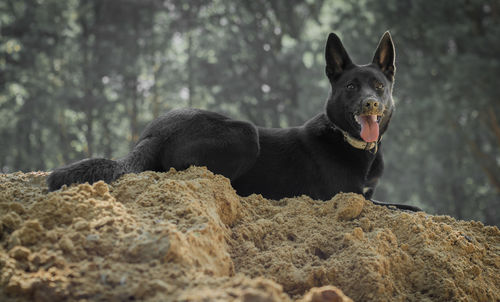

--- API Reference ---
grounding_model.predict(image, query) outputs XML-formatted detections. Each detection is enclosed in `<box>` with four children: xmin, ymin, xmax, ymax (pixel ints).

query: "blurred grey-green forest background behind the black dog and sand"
<box><xmin>0</xmin><ymin>0</ymin><xmax>500</xmax><ymax>225</ymax></box>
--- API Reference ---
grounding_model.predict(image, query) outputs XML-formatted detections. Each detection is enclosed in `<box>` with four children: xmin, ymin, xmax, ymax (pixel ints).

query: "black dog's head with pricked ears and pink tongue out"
<box><xmin>325</xmin><ymin>32</ymin><xmax>396</xmax><ymax>142</ymax></box>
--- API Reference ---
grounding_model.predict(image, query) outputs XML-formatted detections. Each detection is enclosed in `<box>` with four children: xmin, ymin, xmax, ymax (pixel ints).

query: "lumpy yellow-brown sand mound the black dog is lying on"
<box><xmin>0</xmin><ymin>168</ymin><xmax>500</xmax><ymax>302</ymax></box>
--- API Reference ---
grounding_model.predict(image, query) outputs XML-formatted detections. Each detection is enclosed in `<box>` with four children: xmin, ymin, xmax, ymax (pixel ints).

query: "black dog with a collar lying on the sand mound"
<box><xmin>47</xmin><ymin>32</ymin><xmax>418</xmax><ymax>210</ymax></box>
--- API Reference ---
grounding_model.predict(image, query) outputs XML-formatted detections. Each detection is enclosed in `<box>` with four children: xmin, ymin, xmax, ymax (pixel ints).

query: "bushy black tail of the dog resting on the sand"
<box><xmin>47</xmin><ymin>137</ymin><xmax>159</xmax><ymax>191</ymax></box>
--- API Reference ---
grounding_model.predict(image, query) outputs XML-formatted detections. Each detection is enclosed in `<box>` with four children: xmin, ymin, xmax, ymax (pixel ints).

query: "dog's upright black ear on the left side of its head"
<box><xmin>325</xmin><ymin>33</ymin><xmax>352</xmax><ymax>80</ymax></box>
